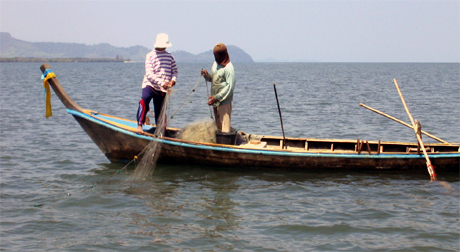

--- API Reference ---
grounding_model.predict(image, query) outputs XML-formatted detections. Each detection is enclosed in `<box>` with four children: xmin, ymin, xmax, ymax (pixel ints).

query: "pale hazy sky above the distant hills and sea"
<box><xmin>0</xmin><ymin>0</ymin><xmax>460</xmax><ymax>62</ymax></box>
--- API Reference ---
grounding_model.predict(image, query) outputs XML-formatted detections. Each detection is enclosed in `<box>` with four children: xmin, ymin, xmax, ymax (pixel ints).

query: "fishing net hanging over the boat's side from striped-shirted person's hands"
<box><xmin>131</xmin><ymin>92</ymin><xmax>171</xmax><ymax>179</ymax></box>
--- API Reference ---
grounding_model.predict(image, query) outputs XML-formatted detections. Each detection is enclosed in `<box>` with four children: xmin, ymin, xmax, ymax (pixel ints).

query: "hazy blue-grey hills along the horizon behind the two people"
<box><xmin>0</xmin><ymin>32</ymin><xmax>254</xmax><ymax>63</ymax></box>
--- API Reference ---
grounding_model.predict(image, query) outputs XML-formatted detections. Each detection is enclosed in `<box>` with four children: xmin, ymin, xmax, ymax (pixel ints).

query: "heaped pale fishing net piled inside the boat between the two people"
<box><xmin>177</xmin><ymin>119</ymin><xmax>217</xmax><ymax>143</ymax></box>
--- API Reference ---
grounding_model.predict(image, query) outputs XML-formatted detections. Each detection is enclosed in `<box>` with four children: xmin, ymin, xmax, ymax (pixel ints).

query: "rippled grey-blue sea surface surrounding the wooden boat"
<box><xmin>0</xmin><ymin>63</ymin><xmax>460</xmax><ymax>251</ymax></box>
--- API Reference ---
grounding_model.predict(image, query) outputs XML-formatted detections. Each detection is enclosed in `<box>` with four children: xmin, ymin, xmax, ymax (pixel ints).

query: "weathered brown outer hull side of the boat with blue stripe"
<box><xmin>68</xmin><ymin>110</ymin><xmax>460</xmax><ymax>172</ymax></box>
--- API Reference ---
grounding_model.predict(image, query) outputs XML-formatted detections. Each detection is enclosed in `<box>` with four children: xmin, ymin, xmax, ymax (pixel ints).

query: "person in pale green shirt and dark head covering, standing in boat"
<box><xmin>201</xmin><ymin>43</ymin><xmax>235</xmax><ymax>132</ymax></box>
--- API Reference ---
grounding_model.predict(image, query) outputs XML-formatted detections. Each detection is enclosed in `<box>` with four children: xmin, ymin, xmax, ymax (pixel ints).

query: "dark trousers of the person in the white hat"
<box><xmin>137</xmin><ymin>86</ymin><xmax>165</xmax><ymax>125</ymax></box>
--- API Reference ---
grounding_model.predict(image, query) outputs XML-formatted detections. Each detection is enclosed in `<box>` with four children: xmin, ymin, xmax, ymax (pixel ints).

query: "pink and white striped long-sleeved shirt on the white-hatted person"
<box><xmin>142</xmin><ymin>49</ymin><xmax>177</xmax><ymax>92</ymax></box>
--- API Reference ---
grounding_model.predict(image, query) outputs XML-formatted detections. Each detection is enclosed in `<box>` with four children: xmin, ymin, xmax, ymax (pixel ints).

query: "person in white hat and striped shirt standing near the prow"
<box><xmin>137</xmin><ymin>33</ymin><xmax>178</xmax><ymax>134</ymax></box>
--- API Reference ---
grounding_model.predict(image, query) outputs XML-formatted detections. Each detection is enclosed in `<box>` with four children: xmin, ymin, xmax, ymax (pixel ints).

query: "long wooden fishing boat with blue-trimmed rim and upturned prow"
<box><xmin>41</xmin><ymin>64</ymin><xmax>460</xmax><ymax>173</ymax></box>
